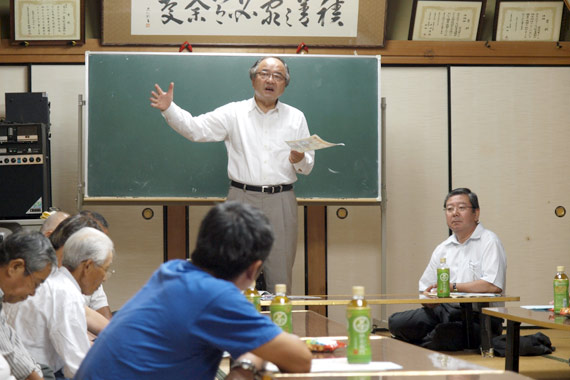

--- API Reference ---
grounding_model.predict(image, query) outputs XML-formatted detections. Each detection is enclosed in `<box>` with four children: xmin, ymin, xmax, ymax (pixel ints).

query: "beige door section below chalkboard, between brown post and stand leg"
<box><xmin>327</xmin><ymin>205</ymin><xmax>382</xmax><ymax>324</ymax></box>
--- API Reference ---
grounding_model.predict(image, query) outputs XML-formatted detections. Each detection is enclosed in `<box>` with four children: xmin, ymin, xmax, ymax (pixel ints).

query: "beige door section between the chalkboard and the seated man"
<box><xmin>378</xmin><ymin>67</ymin><xmax>448</xmax><ymax>316</ymax></box>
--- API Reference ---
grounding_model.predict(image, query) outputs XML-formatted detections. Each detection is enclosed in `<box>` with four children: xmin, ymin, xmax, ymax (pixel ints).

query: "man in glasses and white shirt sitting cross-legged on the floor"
<box><xmin>388</xmin><ymin>188</ymin><xmax>507</xmax><ymax>351</ymax></box>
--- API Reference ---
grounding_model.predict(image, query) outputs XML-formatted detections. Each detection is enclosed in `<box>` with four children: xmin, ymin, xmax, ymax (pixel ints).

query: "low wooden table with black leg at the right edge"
<box><xmin>483</xmin><ymin>307</ymin><xmax>570</xmax><ymax>372</ymax></box>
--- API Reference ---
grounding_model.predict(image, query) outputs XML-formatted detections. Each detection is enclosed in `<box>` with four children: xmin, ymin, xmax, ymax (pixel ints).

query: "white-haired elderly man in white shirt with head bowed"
<box><xmin>6</xmin><ymin>227</ymin><xmax>114</xmax><ymax>379</ymax></box>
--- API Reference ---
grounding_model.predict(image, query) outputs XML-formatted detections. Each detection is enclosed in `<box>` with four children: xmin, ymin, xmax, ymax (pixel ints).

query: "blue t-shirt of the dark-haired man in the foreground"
<box><xmin>75</xmin><ymin>260</ymin><xmax>281</xmax><ymax>380</ymax></box>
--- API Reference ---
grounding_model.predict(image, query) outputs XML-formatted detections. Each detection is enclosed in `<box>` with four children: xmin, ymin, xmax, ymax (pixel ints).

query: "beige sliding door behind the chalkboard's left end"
<box><xmin>32</xmin><ymin>65</ymin><xmax>163</xmax><ymax>310</ymax></box>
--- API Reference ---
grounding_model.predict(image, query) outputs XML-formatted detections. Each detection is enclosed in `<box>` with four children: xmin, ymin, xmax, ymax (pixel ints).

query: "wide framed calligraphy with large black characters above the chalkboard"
<box><xmin>101</xmin><ymin>0</ymin><xmax>387</xmax><ymax>47</ymax></box>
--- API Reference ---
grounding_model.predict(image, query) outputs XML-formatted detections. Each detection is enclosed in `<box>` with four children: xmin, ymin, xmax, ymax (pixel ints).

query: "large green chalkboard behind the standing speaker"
<box><xmin>83</xmin><ymin>53</ymin><xmax>381</xmax><ymax>201</ymax></box>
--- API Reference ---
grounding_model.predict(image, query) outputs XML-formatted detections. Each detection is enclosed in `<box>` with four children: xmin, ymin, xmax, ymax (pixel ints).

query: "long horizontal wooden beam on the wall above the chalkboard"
<box><xmin>0</xmin><ymin>39</ymin><xmax>570</xmax><ymax>65</ymax></box>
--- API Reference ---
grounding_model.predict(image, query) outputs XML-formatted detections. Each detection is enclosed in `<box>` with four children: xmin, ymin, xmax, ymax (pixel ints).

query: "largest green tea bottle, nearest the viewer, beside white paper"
<box><xmin>346</xmin><ymin>286</ymin><xmax>372</xmax><ymax>363</ymax></box>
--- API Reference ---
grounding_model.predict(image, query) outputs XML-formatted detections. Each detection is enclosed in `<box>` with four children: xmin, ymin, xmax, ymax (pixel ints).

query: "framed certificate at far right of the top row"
<box><xmin>493</xmin><ymin>0</ymin><xmax>564</xmax><ymax>41</ymax></box>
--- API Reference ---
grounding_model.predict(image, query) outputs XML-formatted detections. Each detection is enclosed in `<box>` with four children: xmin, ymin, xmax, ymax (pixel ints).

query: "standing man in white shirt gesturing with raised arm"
<box><xmin>150</xmin><ymin>57</ymin><xmax>315</xmax><ymax>291</ymax></box>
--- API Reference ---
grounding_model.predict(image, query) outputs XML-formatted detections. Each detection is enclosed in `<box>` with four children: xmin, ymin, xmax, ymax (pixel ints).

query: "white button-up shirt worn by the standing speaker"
<box><xmin>162</xmin><ymin>98</ymin><xmax>315</xmax><ymax>186</ymax></box>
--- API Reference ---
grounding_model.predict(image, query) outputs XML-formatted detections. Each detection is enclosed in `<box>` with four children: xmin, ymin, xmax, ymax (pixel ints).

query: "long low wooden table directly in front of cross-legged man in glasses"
<box><xmin>261</xmin><ymin>293</ymin><xmax>520</xmax><ymax>350</ymax></box>
